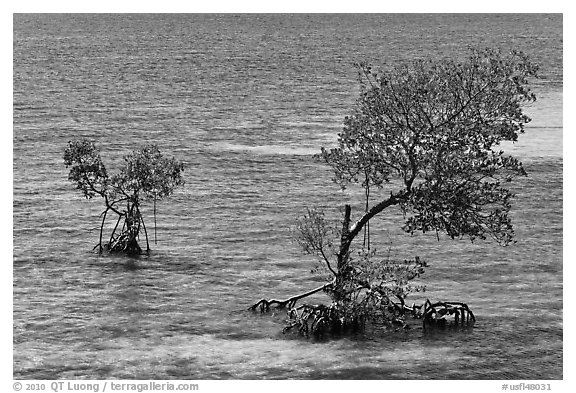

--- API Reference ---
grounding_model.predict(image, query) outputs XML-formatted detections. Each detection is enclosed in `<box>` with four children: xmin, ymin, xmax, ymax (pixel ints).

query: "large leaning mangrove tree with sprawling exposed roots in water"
<box><xmin>250</xmin><ymin>49</ymin><xmax>537</xmax><ymax>333</ymax></box>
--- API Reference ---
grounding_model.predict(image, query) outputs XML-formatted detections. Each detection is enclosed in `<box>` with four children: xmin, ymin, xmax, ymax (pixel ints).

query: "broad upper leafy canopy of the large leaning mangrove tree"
<box><xmin>320</xmin><ymin>49</ymin><xmax>537</xmax><ymax>244</ymax></box>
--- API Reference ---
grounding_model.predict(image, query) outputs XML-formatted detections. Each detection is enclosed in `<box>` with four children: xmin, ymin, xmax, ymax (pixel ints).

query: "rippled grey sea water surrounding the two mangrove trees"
<box><xmin>13</xmin><ymin>14</ymin><xmax>563</xmax><ymax>379</ymax></box>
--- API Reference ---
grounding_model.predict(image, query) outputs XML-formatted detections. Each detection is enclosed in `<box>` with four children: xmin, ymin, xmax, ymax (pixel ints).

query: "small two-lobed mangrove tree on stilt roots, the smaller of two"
<box><xmin>64</xmin><ymin>140</ymin><xmax>184</xmax><ymax>254</ymax></box>
